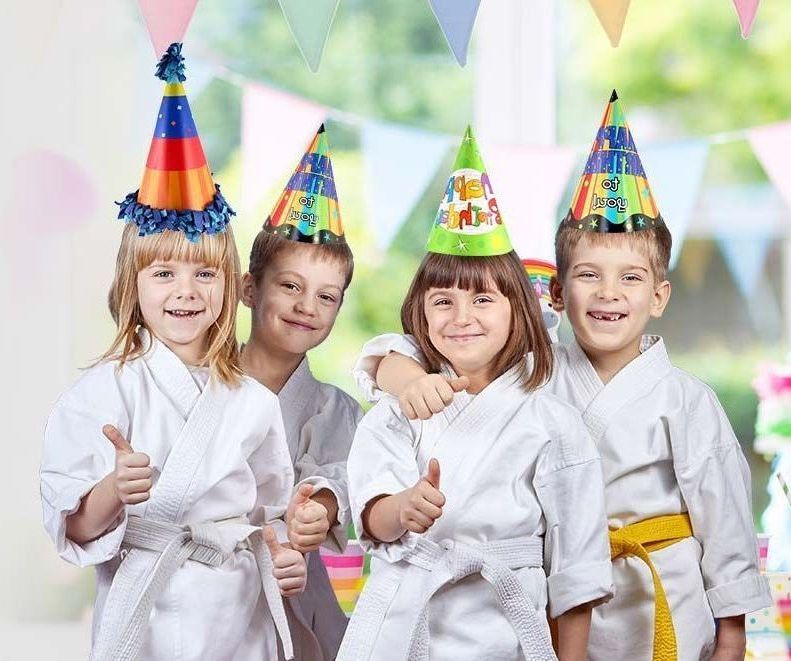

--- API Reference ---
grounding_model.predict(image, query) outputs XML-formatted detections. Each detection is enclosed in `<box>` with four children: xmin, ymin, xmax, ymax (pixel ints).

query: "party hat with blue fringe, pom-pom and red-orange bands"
<box><xmin>118</xmin><ymin>43</ymin><xmax>236</xmax><ymax>241</ymax></box>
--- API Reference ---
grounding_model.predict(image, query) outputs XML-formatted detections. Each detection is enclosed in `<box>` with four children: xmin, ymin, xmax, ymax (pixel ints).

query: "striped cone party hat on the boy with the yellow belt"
<box><xmin>563</xmin><ymin>90</ymin><xmax>664</xmax><ymax>232</ymax></box>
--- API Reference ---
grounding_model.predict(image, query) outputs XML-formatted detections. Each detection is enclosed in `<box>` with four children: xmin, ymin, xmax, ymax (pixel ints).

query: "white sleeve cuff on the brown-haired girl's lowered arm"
<box><xmin>547</xmin><ymin>561</ymin><xmax>615</xmax><ymax>618</ymax></box>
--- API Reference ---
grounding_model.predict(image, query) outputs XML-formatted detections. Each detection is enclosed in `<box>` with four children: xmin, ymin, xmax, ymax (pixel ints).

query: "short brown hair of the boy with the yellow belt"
<box><xmin>555</xmin><ymin>222</ymin><xmax>673</xmax><ymax>282</ymax></box>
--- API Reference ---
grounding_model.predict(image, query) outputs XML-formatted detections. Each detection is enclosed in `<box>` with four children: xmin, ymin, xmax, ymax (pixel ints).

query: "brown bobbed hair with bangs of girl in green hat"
<box><xmin>401</xmin><ymin>251</ymin><xmax>553</xmax><ymax>391</ymax></box>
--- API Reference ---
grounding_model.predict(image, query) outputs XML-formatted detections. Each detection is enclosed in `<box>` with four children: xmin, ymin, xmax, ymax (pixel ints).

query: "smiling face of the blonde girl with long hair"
<box><xmin>137</xmin><ymin>261</ymin><xmax>225</xmax><ymax>364</ymax></box>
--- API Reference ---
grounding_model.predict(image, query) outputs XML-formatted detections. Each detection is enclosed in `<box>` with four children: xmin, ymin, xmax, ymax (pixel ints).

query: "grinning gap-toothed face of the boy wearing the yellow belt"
<box><xmin>553</xmin><ymin>239</ymin><xmax>670</xmax><ymax>360</ymax></box>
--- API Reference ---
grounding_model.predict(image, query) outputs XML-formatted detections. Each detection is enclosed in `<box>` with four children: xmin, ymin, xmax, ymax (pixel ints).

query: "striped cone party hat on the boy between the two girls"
<box><xmin>264</xmin><ymin>124</ymin><xmax>346</xmax><ymax>243</ymax></box>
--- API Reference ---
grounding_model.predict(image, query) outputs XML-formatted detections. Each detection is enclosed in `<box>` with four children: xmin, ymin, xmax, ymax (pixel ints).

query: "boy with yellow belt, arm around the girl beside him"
<box><xmin>352</xmin><ymin>92</ymin><xmax>771</xmax><ymax>661</ymax></box>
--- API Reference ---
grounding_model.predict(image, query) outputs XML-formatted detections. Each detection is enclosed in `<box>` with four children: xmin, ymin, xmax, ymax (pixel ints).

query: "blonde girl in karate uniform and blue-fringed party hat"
<box><xmin>41</xmin><ymin>44</ymin><xmax>306</xmax><ymax>661</ymax></box>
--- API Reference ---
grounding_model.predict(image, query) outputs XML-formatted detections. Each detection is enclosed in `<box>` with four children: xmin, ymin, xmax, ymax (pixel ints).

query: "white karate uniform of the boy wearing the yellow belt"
<box><xmin>355</xmin><ymin>335</ymin><xmax>772</xmax><ymax>661</ymax></box>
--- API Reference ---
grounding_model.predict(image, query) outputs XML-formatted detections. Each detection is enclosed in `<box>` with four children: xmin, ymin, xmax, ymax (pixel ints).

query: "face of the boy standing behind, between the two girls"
<box><xmin>242</xmin><ymin>244</ymin><xmax>346</xmax><ymax>355</ymax></box>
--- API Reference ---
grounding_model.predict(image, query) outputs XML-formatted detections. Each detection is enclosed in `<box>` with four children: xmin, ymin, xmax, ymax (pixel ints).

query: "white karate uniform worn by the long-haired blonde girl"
<box><xmin>41</xmin><ymin>334</ymin><xmax>294</xmax><ymax>661</ymax></box>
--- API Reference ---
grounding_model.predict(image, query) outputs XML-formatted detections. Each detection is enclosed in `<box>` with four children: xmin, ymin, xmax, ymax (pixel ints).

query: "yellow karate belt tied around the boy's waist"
<box><xmin>610</xmin><ymin>514</ymin><xmax>692</xmax><ymax>661</ymax></box>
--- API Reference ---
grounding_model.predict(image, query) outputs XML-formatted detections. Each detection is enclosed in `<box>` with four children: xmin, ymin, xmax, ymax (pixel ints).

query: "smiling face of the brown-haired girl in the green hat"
<box><xmin>423</xmin><ymin>284</ymin><xmax>511</xmax><ymax>383</ymax></box>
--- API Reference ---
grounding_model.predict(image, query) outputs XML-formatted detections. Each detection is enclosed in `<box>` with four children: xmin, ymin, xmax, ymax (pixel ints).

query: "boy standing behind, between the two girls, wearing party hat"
<box><xmin>242</xmin><ymin>126</ymin><xmax>362</xmax><ymax>660</ymax></box>
